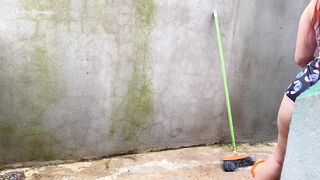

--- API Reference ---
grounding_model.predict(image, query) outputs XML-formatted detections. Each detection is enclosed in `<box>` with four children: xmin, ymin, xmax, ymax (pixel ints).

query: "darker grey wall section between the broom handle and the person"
<box><xmin>227</xmin><ymin>0</ymin><xmax>309</xmax><ymax>142</ymax></box>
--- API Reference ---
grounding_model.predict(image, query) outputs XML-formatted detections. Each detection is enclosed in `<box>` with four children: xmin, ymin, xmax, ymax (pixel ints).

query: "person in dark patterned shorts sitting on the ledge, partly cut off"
<box><xmin>254</xmin><ymin>0</ymin><xmax>320</xmax><ymax>180</ymax></box>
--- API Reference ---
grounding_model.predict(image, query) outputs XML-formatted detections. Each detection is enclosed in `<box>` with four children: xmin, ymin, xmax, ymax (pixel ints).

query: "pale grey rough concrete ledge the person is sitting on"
<box><xmin>281</xmin><ymin>83</ymin><xmax>320</xmax><ymax>180</ymax></box>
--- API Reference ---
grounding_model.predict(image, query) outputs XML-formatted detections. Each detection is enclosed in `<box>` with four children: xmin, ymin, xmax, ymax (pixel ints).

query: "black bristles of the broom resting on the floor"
<box><xmin>222</xmin><ymin>157</ymin><xmax>255</xmax><ymax>172</ymax></box>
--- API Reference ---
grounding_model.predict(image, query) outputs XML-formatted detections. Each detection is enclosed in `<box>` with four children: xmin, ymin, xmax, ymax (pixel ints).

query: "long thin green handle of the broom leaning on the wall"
<box><xmin>213</xmin><ymin>11</ymin><xmax>237</xmax><ymax>152</ymax></box>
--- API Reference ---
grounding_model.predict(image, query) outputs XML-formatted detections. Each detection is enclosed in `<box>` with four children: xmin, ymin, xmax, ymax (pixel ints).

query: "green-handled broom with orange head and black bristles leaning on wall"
<box><xmin>213</xmin><ymin>10</ymin><xmax>255</xmax><ymax>172</ymax></box>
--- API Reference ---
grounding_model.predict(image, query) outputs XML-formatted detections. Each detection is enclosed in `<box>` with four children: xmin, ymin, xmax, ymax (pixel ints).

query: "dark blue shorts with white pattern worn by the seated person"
<box><xmin>285</xmin><ymin>57</ymin><xmax>320</xmax><ymax>102</ymax></box>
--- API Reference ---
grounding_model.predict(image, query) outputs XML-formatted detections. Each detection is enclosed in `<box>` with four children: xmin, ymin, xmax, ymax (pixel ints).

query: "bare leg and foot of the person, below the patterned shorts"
<box><xmin>254</xmin><ymin>96</ymin><xmax>294</xmax><ymax>180</ymax></box>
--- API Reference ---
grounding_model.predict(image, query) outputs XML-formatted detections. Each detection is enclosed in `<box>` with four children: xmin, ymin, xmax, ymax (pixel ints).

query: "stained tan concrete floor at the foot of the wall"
<box><xmin>0</xmin><ymin>144</ymin><xmax>275</xmax><ymax>180</ymax></box>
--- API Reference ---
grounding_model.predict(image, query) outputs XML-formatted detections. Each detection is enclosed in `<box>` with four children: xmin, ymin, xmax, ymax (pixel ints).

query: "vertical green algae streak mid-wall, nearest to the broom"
<box><xmin>109</xmin><ymin>0</ymin><xmax>155</xmax><ymax>141</ymax></box>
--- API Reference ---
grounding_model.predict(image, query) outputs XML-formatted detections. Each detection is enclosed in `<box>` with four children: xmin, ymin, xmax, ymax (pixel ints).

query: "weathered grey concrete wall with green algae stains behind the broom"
<box><xmin>0</xmin><ymin>0</ymin><xmax>307</xmax><ymax>164</ymax></box>
